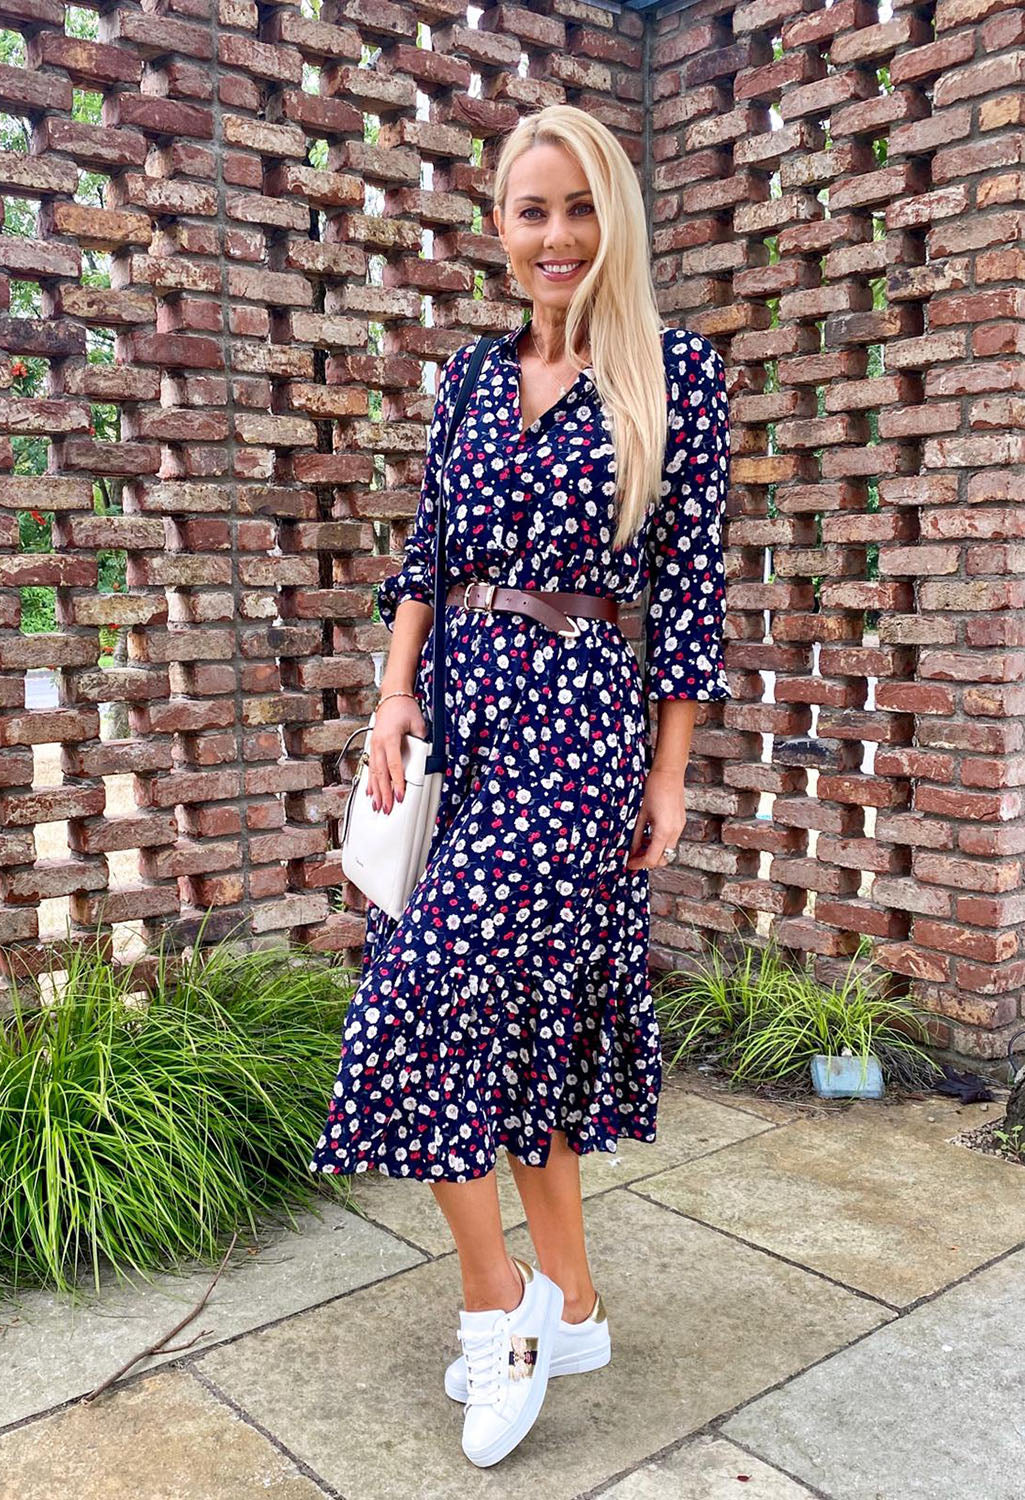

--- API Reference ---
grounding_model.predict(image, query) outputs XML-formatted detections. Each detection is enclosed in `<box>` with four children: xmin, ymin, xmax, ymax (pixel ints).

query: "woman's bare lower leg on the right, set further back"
<box><xmin>507</xmin><ymin>1131</ymin><xmax>596</xmax><ymax>1323</ymax></box>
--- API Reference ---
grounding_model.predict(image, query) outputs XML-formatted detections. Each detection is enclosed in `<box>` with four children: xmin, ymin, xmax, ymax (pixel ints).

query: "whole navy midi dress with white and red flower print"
<box><xmin>309</xmin><ymin>327</ymin><xmax>731</xmax><ymax>1182</ymax></box>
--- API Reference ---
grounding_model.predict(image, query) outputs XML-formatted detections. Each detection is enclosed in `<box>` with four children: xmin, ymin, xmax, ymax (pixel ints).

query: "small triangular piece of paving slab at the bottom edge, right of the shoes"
<box><xmin>602</xmin><ymin>1436</ymin><xmax>812</xmax><ymax>1500</ymax></box>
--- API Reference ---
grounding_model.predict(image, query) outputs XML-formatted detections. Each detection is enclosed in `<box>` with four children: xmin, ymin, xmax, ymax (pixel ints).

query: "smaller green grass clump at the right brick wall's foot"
<box><xmin>656</xmin><ymin>939</ymin><xmax>930</xmax><ymax>1085</ymax></box>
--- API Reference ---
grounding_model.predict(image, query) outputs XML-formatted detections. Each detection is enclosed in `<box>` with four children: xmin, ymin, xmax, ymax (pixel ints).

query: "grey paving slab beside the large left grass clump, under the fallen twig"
<box><xmin>0</xmin><ymin>1200</ymin><xmax>420</xmax><ymax>1425</ymax></box>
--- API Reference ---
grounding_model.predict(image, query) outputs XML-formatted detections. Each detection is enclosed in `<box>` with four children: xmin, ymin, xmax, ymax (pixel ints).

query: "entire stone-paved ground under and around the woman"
<box><xmin>0</xmin><ymin>1076</ymin><xmax>1025</xmax><ymax>1500</ymax></box>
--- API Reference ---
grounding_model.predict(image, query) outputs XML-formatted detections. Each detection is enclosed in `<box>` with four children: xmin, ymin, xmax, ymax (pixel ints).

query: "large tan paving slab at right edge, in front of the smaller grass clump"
<box><xmin>636</xmin><ymin>1110</ymin><xmax>1025</xmax><ymax>1308</ymax></box>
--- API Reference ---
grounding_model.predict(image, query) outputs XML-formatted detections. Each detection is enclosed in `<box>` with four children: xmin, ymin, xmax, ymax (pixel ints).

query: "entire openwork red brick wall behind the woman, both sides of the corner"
<box><xmin>0</xmin><ymin>0</ymin><xmax>1025</xmax><ymax>1056</ymax></box>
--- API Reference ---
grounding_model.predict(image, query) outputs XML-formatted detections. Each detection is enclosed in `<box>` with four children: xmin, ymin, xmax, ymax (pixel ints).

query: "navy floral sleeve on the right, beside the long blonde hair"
<box><xmin>644</xmin><ymin>330</ymin><xmax>732</xmax><ymax>701</ymax></box>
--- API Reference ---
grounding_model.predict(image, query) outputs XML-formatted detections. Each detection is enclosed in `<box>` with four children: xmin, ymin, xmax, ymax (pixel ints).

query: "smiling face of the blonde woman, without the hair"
<box><xmin>495</xmin><ymin>144</ymin><xmax>600</xmax><ymax>311</ymax></box>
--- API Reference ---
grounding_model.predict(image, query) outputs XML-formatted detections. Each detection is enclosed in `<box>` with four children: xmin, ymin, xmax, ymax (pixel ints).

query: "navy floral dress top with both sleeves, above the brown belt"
<box><xmin>377</xmin><ymin>320</ymin><xmax>731</xmax><ymax>699</ymax></box>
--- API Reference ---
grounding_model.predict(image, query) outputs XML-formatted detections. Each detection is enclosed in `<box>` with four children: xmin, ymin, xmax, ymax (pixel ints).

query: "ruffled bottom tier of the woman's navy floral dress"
<box><xmin>308</xmin><ymin>906</ymin><xmax>662</xmax><ymax>1182</ymax></box>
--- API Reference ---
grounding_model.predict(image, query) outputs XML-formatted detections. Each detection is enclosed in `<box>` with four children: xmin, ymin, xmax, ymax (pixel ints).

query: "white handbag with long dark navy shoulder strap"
<box><xmin>338</xmin><ymin>339</ymin><xmax>495</xmax><ymax>918</ymax></box>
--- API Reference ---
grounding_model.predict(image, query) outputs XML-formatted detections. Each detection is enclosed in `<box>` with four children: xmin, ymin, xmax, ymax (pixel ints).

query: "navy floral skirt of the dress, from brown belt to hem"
<box><xmin>309</xmin><ymin>605</ymin><xmax>662</xmax><ymax>1182</ymax></box>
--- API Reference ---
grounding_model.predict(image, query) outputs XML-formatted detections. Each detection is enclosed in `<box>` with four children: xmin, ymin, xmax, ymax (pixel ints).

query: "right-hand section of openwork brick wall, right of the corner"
<box><xmin>650</xmin><ymin>0</ymin><xmax>1025</xmax><ymax>1058</ymax></box>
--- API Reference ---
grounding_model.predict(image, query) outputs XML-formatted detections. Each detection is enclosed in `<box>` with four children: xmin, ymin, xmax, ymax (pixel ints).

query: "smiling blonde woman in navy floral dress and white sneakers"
<box><xmin>311</xmin><ymin>105</ymin><xmax>731</xmax><ymax>1467</ymax></box>
